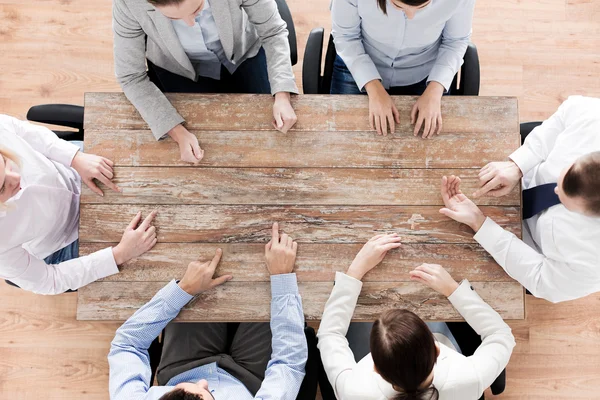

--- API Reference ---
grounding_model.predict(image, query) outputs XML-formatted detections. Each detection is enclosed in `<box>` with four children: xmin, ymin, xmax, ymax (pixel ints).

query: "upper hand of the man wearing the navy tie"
<box><xmin>473</xmin><ymin>161</ymin><xmax>523</xmax><ymax>197</ymax></box>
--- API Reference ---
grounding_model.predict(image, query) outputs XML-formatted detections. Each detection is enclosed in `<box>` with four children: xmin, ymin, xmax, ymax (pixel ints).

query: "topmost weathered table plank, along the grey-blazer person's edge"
<box><xmin>85</xmin><ymin>93</ymin><xmax>519</xmax><ymax>134</ymax></box>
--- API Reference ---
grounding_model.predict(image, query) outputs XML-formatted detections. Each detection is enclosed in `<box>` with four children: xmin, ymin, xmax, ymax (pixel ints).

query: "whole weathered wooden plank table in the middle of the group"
<box><xmin>77</xmin><ymin>93</ymin><xmax>525</xmax><ymax>321</ymax></box>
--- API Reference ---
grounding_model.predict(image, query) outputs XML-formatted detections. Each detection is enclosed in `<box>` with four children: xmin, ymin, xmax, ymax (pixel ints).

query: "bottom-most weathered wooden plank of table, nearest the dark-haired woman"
<box><xmin>77</xmin><ymin>281</ymin><xmax>524</xmax><ymax>322</ymax></box>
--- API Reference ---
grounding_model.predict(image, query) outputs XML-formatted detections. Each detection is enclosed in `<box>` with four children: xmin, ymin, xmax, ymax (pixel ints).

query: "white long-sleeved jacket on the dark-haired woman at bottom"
<box><xmin>317</xmin><ymin>272</ymin><xmax>515</xmax><ymax>400</ymax></box>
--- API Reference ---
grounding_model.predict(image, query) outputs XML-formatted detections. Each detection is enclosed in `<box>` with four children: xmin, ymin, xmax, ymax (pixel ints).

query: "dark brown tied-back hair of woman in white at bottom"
<box><xmin>371</xmin><ymin>309</ymin><xmax>439</xmax><ymax>400</ymax></box>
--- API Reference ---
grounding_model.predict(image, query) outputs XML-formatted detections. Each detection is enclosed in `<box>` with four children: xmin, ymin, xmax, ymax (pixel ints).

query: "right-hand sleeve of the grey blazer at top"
<box><xmin>242</xmin><ymin>0</ymin><xmax>298</xmax><ymax>95</ymax></box>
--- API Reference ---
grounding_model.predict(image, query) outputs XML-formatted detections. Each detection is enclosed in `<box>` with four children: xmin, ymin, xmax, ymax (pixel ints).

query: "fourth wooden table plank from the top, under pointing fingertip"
<box><xmin>79</xmin><ymin>204</ymin><xmax>521</xmax><ymax>244</ymax></box>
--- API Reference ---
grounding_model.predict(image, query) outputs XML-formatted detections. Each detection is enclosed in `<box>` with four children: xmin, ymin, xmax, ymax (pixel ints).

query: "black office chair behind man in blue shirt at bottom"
<box><xmin>148</xmin><ymin>326</ymin><xmax>323</xmax><ymax>400</ymax></box>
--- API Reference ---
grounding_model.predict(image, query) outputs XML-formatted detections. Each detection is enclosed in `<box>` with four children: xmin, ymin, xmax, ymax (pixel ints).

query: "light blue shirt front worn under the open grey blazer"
<box><xmin>171</xmin><ymin>0</ymin><xmax>237</xmax><ymax>80</ymax></box>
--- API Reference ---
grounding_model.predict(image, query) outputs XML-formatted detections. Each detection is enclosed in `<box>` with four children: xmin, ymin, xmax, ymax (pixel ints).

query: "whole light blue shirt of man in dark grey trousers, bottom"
<box><xmin>108</xmin><ymin>274</ymin><xmax>308</xmax><ymax>400</ymax></box>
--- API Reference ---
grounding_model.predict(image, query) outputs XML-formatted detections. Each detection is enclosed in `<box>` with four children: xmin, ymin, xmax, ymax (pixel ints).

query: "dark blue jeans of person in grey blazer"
<box><xmin>148</xmin><ymin>47</ymin><xmax>271</xmax><ymax>94</ymax></box>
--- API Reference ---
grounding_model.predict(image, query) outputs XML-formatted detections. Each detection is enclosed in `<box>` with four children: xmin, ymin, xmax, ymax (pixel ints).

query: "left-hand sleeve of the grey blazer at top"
<box><xmin>113</xmin><ymin>0</ymin><xmax>185</xmax><ymax>140</ymax></box>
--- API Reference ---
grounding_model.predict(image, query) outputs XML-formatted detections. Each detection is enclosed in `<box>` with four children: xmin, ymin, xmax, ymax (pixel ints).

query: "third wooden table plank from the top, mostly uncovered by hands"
<box><xmin>81</xmin><ymin>167</ymin><xmax>521</xmax><ymax>206</ymax></box>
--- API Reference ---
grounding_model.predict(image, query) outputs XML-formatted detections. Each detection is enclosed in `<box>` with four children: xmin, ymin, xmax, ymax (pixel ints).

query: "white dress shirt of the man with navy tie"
<box><xmin>475</xmin><ymin>96</ymin><xmax>600</xmax><ymax>303</ymax></box>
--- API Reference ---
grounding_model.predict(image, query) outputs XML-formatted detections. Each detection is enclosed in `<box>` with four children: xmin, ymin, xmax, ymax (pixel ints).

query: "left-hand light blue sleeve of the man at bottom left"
<box><xmin>108</xmin><ymin>280</ymin><xmax>193</xmax><ymax>400</ymax></box>
